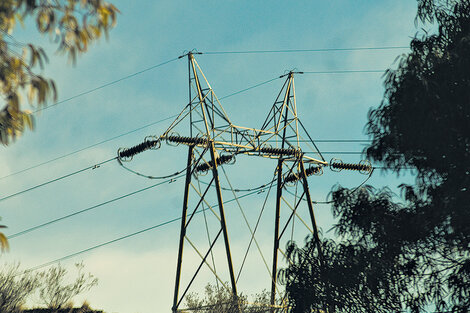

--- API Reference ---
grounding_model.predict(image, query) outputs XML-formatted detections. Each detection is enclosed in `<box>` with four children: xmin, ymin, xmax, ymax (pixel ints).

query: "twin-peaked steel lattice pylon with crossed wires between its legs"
<box><xmin>114</xmin><ymin>53</ymin><xmax>372</xmax><ymax>312</ymax></box>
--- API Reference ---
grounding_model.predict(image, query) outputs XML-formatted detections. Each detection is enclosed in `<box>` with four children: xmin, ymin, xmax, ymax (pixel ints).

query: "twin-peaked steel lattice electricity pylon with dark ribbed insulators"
<box><xmin>119</xmin><ymin>53</ymin><xmax>370</xmax><ymax>312</ymax></box>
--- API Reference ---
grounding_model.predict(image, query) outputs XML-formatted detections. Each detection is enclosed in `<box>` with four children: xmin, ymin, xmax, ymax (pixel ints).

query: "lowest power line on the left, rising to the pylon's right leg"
<box><xmin>25</xmin><ymin>186</ymin><xmax>268</xmax><ymax>273</ymax></box>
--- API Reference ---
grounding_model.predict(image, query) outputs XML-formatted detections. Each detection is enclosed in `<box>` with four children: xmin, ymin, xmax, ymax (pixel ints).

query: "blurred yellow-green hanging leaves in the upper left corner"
<box><xmin>0</xmin><ymin>0</ymin><xmax>118</xmax><ymax>145</ymax></box>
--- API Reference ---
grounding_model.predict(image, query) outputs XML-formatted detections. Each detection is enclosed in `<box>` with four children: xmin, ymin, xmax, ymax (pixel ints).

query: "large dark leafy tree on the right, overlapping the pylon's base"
<box><xmin>280</xmin><ymin>0</ymin><xmax>470</xmax><ymax>313</ymax></box>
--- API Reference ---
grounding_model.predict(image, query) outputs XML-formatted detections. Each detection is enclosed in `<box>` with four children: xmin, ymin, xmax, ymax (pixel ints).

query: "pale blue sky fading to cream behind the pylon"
<box><xmin>0</xmin><ymin>0</ymin><xmax>417</xmax><ymax>313</ymax></box>
